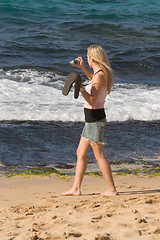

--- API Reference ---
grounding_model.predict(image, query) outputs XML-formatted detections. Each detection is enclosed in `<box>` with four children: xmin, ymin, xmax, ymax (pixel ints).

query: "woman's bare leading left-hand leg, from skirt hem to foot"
<box><xmin>61</xmin><ymin>137</ymin><xmax>90</xmax><ymax>196</ymax></box>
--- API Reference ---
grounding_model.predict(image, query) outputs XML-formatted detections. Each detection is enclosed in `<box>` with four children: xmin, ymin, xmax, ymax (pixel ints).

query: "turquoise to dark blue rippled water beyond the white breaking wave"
<box><xmin>0</xmin><ymin>0</ymin><xmax>160</xmax><ymax>84</ymax></box>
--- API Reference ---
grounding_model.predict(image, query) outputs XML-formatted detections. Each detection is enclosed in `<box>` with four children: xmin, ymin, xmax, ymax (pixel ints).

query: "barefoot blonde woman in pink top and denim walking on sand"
<box><xmin>61</xmin><ymin>45</ymin><xmax>117</xmax><ymax>196</ymax></box>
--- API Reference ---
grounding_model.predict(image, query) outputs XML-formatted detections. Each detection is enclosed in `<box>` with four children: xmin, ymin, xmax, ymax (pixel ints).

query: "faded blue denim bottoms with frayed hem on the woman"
<box><xmin>81</xmin><ymin>118</ymin><xmax>106</xmax><ymax>143</ymax></box>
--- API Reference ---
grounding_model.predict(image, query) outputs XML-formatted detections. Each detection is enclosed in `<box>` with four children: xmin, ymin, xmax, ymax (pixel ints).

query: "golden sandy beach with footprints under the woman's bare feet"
<box><xmin>0</xmin><ymin>172</ymin><xmax>160</xmax><ymax>240</ymax></box>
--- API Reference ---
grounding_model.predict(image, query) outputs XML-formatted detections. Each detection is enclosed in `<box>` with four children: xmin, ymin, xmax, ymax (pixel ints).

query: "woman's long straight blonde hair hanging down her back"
<box><xmin>87</xmin><ymin>45</ymin><xmax>113</xmax><ymax>94</ymax></box>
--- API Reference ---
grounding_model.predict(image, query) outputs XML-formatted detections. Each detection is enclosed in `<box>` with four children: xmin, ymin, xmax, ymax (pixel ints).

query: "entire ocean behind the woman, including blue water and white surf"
<box><xmin>0</xmin><ymin>0</ymin><xmax>160</xmax><ymax>172</ymax></box>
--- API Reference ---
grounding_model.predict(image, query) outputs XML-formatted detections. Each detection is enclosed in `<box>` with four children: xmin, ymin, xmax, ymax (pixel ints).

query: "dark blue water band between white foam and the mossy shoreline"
<box><xmin>0</xmin><ymin>122</ymin><xmax>160</xmax><ymax>170</ymax></box>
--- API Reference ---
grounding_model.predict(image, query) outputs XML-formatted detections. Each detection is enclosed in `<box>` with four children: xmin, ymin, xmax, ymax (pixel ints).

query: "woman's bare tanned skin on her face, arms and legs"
<box><xmin>61</xmin><ymin>54</ymin><xmax>117</xmax><ymax>196</ymax></box>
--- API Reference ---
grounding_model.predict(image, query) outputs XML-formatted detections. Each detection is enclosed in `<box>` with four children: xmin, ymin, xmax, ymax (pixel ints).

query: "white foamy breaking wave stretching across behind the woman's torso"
<box><xmin>0</xmin><ymin>70</ymin><xmax>160</xmax><ymax>122</ymax></box>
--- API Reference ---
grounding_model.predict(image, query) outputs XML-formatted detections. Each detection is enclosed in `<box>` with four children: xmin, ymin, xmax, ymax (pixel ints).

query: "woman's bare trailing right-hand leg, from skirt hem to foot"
<box><xmin>91</xmin><ymin>142</ymin><xmax>117</xmax><ymax>195</ymax></box>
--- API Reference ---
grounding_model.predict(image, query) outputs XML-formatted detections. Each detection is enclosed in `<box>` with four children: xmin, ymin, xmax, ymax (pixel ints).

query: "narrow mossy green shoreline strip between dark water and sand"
<box><xmin>0</xmin><ymin>156</ymin><xmax>160</xmax><ymax>177</ymax></box>
